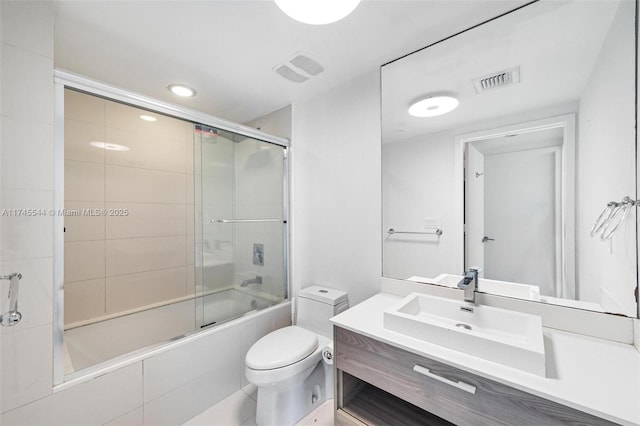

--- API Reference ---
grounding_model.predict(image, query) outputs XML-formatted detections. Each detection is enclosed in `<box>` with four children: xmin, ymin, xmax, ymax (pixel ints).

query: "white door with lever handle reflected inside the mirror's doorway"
<box><xmin>482</xmin><ymin>148</ymin><xmax>560</xmax><ymax>296</ymax></box>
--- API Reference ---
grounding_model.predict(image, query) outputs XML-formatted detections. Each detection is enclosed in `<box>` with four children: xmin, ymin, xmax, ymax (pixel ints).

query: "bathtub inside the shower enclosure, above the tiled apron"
<box><xmin>64</xmin><ymin>288</ymin><xmax>279</xmax><ymax>375</ymax></box>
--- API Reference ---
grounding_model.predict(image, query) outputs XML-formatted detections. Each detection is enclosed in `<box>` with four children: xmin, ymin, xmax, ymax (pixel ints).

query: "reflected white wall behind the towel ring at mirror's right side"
<box><xmin>576</xmin><ymin>1</ymin><xmax>637</xmax><ymax>316</ymax></box>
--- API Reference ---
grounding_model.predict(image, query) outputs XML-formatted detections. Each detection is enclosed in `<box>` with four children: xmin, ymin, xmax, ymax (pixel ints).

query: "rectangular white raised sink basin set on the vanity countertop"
<box><xmin>384</xmin><ymin>293</ymin><xmax>545</xmax><ymax>376</ymax></box>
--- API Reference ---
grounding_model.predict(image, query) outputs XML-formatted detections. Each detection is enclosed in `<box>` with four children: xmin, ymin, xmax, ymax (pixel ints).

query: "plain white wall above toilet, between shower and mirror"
<box><xmin>291</xmin><ymin>71</ymin><xmax>382</xmax><ymax>304</ymax></box>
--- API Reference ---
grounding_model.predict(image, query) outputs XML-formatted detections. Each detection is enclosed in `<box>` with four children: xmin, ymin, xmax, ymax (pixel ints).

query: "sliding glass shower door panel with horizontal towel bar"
<box><xmin>196</xmin><ymin>126</ymin><xmax>288</xmax><ymax>327</ymax></box>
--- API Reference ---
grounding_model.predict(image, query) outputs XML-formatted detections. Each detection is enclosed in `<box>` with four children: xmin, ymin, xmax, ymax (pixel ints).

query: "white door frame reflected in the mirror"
<box><xmin>453</xmin><ymin>114</ymin><xmax>576</xmax><ymax>299</ymax></box>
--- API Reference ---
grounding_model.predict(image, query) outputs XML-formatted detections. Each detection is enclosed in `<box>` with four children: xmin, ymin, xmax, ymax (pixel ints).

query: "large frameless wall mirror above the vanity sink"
<box><xmin>382</xmin><ymin>0</ymin><xmax>638</xmax><ymax>317</ymax></box>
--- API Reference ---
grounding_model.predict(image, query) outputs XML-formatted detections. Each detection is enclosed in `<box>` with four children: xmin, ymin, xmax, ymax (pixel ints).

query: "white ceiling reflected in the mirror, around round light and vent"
<box><xmin>382</xmin><ymin>0</ymin><xmax>620</xmax><ymax>143</ymax></box>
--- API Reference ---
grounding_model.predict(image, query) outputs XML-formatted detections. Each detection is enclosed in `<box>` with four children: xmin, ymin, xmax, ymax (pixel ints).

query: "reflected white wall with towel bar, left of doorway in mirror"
<box><xmin>382</xmin><ymin>132</ymin><xmax>463</xmax><ymax>279</ymax></box>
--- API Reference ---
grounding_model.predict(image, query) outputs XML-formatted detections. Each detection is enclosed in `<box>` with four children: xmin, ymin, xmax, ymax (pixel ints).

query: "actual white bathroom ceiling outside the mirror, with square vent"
<box><xmin>55</xmin><ymin>0</ymin><xmax>526</xmax><ymax>123</ymax></box>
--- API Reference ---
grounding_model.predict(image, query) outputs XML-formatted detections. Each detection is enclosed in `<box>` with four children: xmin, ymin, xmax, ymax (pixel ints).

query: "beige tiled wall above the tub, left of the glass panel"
<box><xmin>64</xmin><ymin>89</ymin><xmax>194</xmax><ymax>326</ymax></box>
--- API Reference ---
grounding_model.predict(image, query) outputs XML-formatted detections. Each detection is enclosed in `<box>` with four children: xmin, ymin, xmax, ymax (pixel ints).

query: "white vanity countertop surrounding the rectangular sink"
<box><xmin>332</xmin><ymin>293</ymin><xmax>640</xmax><ymax>425</ymax></box>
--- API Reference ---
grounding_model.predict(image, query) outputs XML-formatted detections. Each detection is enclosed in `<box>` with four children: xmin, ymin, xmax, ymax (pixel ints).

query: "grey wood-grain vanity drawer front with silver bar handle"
<box><xmin>334</xmin><ymin>327</ymin><xmax>614</xmax><ymax>426</ymax></box>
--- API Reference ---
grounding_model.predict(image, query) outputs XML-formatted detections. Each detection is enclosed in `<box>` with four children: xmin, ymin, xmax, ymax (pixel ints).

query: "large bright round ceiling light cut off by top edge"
<box><xmin>275</xmin><ymin>0</ymin><xmax>360</xmax><ymax>25</ymax></box>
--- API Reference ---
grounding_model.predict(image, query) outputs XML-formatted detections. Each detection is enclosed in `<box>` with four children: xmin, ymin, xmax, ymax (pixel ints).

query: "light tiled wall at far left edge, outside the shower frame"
<box><xmin>0</xmin><ymin>1</ymin><xmax>53</xmax><ymax>414</ymax></box>
